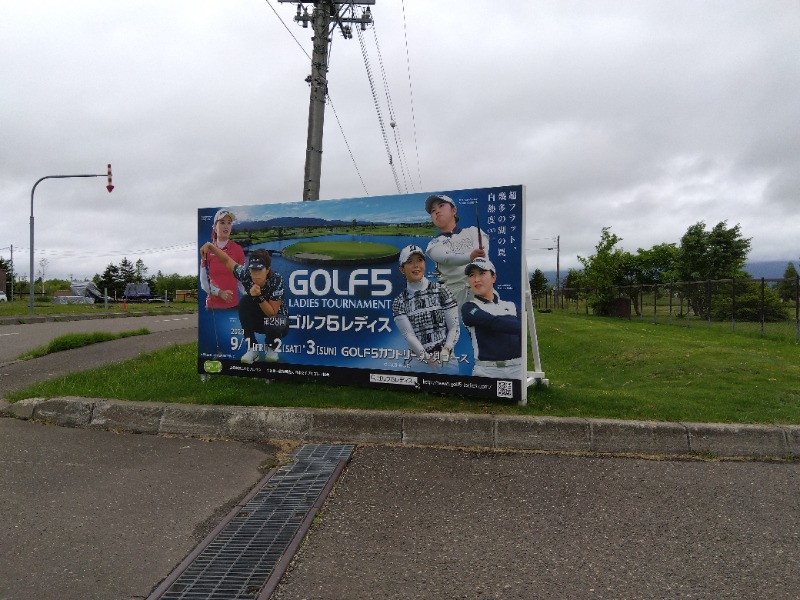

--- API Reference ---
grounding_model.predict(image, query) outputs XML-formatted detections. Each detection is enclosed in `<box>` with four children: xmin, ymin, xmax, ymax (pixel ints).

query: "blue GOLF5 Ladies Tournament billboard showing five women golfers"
<box><xmin>198</xmin><ymin>185</ymin><xmax>528</xmax><ymax>401</ymax></box>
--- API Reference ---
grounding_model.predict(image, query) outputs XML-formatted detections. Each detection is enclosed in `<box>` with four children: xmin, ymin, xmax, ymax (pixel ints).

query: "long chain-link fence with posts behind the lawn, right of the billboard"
<box><xmin>533</xmin><ymin>276</ymin><xmax>800</xmax><ymax>342</ymax></box>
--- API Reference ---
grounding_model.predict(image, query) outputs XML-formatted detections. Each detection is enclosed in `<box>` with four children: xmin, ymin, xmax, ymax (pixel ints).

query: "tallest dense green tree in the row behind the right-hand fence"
<box><xmin>676</xmin><ymin>221</ymin><xmax>750</xmax><ymax>317</ymax></box>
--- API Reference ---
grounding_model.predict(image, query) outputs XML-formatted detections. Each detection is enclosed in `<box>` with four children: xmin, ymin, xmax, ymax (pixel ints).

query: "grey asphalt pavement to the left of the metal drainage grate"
<box><xmin>0</xmin><ymin>419</ymin><xmax>274</xmax><ymax>600</ymax></box>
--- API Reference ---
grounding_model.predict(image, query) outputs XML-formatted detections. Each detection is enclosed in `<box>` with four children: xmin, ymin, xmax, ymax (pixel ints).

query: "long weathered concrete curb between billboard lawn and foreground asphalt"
<box><xmin>0</xmin><ymin>397</ymin><xmax>800</xmax><ymax>458</ymax></box>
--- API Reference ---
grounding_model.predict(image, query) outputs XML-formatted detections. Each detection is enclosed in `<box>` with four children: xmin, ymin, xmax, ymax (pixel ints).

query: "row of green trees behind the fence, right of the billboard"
<box><xmin>530</xmin><ymin>221</ymin><xmax>797</xmax><ymax>320</ymax></box>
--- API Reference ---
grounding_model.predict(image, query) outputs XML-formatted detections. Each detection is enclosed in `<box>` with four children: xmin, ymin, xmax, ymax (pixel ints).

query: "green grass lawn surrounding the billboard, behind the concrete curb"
<box><xmin>9</xmin><ymin>312</ymin><xmax>800</xmax><ymax>424</ymax></box>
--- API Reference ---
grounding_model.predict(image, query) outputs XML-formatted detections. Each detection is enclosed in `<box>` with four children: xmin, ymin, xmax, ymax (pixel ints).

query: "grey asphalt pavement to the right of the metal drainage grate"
<box><xmin>273</xmin><ymin>446</ymin><xmax>800</xmax><ymax>600</ymax></box>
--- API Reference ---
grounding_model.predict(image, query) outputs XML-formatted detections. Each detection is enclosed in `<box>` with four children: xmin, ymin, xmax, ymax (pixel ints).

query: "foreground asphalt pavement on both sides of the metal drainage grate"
<box><xmin>6</xmin><ymin>419</ymin><xmax>800</xmax><ymax>600</ymax></box>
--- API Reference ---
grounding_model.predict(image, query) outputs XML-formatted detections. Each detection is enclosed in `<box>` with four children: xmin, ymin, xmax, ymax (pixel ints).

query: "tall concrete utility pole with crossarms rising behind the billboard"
<box><xmin>278</xmin><ymin>0</ymin><xmax>375</xmax><ymax>201</ymax></box>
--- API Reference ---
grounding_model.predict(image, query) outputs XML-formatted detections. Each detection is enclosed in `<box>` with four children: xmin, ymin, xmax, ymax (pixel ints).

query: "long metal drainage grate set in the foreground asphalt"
<box><xmin>148</xmin><ymin>444</ymin><xmax>354</xmax><ymax>600</ymax></box>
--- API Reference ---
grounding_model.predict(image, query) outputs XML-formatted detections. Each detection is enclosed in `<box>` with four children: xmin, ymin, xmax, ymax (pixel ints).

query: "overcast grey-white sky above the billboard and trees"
<box><xmin>0</xmin><ymin>0</ymin><xmax>800</xmax><ymax>280</ymax></box>
